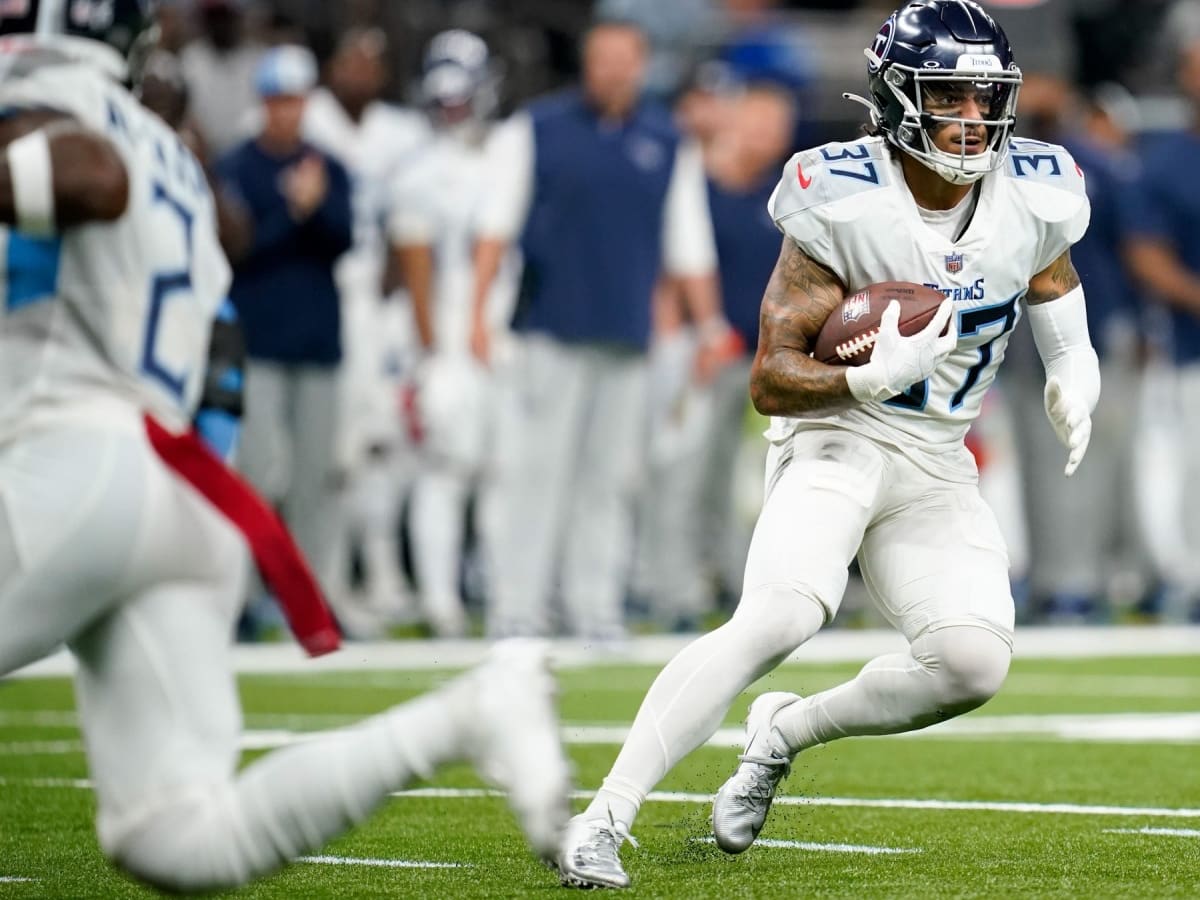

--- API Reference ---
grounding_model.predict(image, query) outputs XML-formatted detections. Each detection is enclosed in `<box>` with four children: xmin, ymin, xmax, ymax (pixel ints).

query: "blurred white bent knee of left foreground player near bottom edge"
<box><xmin>101</xmin><ymin>786</ymin><xmax>270</xmax><ymax>893</ymax></box>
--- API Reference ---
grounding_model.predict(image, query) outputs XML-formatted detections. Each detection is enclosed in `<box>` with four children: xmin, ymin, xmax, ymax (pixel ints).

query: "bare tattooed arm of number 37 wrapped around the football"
<box><xmin>750</xmin><ymin>238</ymin><xmax>856</xmax><ymax>415</ymax></box>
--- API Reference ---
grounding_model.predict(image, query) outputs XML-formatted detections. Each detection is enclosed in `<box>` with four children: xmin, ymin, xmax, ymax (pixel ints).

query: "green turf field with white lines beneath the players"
<box><xmin>0</xmin><ymin>656</ymin><xmax>1200</xmax><ymax>900</ymax></box>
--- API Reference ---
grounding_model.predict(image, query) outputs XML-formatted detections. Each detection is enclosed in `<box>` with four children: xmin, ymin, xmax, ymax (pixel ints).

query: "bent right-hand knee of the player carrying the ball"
<box><xmin>926</xmin><ymin>626</ymin><xmax>1013</xmax><ymax>715</ymax></box>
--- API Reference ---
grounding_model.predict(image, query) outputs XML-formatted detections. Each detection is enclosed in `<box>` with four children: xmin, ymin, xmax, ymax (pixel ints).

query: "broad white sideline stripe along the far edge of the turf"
<box><xmin>14</xmin><ymin>625</ymin><xmax>1200</xmax><ymax>678</ymax></box>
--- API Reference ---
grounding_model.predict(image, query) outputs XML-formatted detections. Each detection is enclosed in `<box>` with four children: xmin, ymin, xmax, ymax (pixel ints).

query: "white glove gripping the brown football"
<box><xmin>846</xmin><ymin>300</ymin><xmax>959</xmax><ymax>403</ymax></box>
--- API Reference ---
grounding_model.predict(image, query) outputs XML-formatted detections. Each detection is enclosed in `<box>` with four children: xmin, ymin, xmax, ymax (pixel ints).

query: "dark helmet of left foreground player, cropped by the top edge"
<box><xmin>0</xmin><ymin>0</ymin><xmax>158</xmax><ymax>80</ymax></box>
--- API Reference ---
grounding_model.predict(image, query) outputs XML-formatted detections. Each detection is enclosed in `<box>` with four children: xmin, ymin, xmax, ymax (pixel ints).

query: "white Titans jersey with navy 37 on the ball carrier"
<box><xmin>768</xmin><ymin>138</ymin><xmax>1091</xmax><ymax>480</ymax></box>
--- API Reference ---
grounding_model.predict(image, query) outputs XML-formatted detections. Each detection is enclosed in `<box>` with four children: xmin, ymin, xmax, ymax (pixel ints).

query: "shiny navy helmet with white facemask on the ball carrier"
<box><xmin>846</xmin><ymin>0</ymin><xmax>1021</xmax><ymax>185</ymax></box>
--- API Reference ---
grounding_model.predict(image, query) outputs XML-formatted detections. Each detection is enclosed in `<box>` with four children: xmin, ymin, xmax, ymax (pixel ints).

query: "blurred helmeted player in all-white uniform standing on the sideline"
<box><xmin>391</xmin><ymin>29</ymin><xmax>516</xmax><ymax>637</ymax></box>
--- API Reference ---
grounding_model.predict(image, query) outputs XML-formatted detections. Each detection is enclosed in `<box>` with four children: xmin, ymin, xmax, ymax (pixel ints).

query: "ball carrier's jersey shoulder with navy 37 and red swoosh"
<box><xmin>770</xmin><ymin>138</ymin><xmax>892</xmax><ymax>227</ymax></box>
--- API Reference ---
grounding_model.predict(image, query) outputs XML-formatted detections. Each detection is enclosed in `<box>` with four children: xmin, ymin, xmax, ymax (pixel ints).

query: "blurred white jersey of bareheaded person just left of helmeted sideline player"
<box><xmin>304</xmin><ymin>89</ymin><xmax>430</xmax><ymax>298</ymax></box>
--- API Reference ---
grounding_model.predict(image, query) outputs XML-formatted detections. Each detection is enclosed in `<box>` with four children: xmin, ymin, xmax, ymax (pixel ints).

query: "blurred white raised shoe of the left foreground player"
<box><xmin>468</xmin><ymin>638</ymin><xmax>571</xmax><ymax>863</ymax></box>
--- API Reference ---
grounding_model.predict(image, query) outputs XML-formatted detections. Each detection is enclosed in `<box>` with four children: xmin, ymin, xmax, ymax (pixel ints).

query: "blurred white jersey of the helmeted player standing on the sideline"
<box><xmin>389</xmin><ymin>131</ymin><xmax>520</xmax><ymax>352</ymax></box>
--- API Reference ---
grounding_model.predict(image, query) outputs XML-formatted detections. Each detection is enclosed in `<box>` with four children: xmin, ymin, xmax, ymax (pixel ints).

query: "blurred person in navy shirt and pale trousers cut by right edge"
<box><xmin>1126</xmin><ymin>35</ymin><xmax>1200</xmax><ymax>620</ymax></box>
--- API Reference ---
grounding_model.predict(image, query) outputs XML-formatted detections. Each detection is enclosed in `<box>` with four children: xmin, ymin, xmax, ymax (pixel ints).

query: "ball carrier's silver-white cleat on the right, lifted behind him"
<box><xmin>713</xmin><ymin>692</ymin><xmax>799</xmax><ymax>853</ymax></box>
